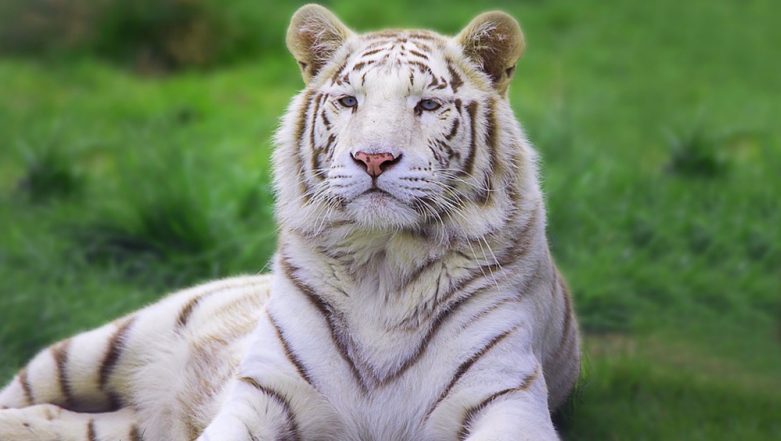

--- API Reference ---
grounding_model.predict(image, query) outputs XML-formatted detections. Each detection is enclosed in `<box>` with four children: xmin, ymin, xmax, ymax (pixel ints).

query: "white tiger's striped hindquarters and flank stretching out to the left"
<box><xmin>0</xmin><ymin>275</ymin><xmax>270</xmax><ymax>441</ymax></box>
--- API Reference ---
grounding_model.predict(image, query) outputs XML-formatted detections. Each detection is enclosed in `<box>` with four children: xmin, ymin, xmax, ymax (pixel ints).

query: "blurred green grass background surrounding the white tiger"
<box><xmin>0</xmin><ymin>0</ymin><xmax>781</xmax><ymax>440</ymax></box>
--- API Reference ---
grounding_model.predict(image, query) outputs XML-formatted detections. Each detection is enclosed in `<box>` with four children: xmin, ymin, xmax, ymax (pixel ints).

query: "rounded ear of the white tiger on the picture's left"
<box><xmin>286</xmin><ymin>4</ymin><xmax>352</xmax><ymax>82</ymax></box>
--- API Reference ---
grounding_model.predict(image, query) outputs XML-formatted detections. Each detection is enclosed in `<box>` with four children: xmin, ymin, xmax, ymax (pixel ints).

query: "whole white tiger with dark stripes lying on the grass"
<box><xmin>0</xmin><ymin>5</ymin><xmax>579</xmax><ymax>441</ymax></box>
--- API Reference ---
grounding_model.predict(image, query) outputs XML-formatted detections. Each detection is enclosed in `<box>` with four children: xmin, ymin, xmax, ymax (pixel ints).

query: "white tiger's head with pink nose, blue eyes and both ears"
<box><xmin>274</xmin><ymin>5</ymin><xmax>536</xmax><ymax>242</ymax></box>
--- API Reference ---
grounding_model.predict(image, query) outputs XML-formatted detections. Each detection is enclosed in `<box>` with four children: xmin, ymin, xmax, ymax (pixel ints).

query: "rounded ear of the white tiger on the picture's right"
<box><xmin>456</xmin><ymin>11</ymin><xmax>526</xmax><ymax>95</ymax></box>
